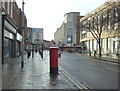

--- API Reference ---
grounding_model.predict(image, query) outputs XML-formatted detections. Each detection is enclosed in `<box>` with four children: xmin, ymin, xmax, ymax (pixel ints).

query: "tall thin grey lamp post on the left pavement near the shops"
<box><xmin>21</xmin><ymin>0</ymin><xmax>25</xmax><ymax>68</ymax></box>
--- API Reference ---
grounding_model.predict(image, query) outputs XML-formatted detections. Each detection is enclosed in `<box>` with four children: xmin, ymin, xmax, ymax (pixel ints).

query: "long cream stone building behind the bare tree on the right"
<box><xmin>80</xmin><ymin>2</ymin><xmax>120</xmax><ymax>58</ymax></box>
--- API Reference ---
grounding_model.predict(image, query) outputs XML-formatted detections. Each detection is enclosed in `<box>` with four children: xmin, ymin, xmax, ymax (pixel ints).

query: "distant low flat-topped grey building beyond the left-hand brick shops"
<box><xmin>25</xmin><ymin>27</ymin><xmax>43</xmax><ymax>50</ymax></box>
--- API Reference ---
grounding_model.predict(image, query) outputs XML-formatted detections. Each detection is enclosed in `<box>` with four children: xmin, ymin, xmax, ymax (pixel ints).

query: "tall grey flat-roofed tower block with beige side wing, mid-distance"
<box><xmin>54</xmin><ymin>12</ymin><xmax>83</xmax><ymax>47</ymax></box>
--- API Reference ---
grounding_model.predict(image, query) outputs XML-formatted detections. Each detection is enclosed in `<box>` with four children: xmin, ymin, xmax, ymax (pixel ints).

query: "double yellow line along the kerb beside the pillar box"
<box><xmin>59</xmin><ymin>66</ymin><xmax>92</xmax><ymax>91</ymax></box>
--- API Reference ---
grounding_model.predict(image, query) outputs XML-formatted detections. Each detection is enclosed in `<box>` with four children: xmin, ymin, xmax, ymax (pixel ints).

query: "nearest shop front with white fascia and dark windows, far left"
<box><xmin>2</xmin><ymin>15</ymin><xmax>18</xmax><ymax>62</ymax></box>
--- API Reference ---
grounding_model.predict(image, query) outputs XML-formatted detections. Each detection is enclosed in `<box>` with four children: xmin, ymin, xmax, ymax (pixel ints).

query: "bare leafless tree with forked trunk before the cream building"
<box><xmin>83</xmin><ymin>5</ymin><xmax>109</xmax><ymax>57</ymax></box>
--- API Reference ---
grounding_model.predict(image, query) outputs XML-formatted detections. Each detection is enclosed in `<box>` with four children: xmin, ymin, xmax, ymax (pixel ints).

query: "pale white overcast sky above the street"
<box><xmin>16</xmin><ymin>0</ymin><xmax>107</xmax><ymax>40</ymax></box>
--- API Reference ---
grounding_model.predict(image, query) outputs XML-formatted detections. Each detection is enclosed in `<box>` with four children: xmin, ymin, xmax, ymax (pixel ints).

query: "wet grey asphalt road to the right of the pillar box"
<box><xmin>59</xmin><ymin>52</ymin><xmax>120</xmax><ymax>89</ymax></box>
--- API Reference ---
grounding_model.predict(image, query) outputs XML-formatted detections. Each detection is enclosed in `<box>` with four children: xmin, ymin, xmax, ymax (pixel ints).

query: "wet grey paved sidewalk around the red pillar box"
<box><xmin>3</xmin><ymin>51</ymin><xmax>77</xmax><ymax>89</ymax></box>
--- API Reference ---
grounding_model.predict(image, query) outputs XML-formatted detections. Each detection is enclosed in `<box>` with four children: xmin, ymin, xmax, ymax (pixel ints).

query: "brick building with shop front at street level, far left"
<box><xmin>2</xmin><ymin>0</ymin><xmax>27</xmax><ymax>62</ymax></box>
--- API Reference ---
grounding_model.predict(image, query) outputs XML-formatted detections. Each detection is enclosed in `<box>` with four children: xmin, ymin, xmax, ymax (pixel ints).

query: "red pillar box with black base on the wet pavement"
<box><xmin>50</xmin><ymin>47</ymin><xmax>58</xmax><ymax>74</ymax></box>
